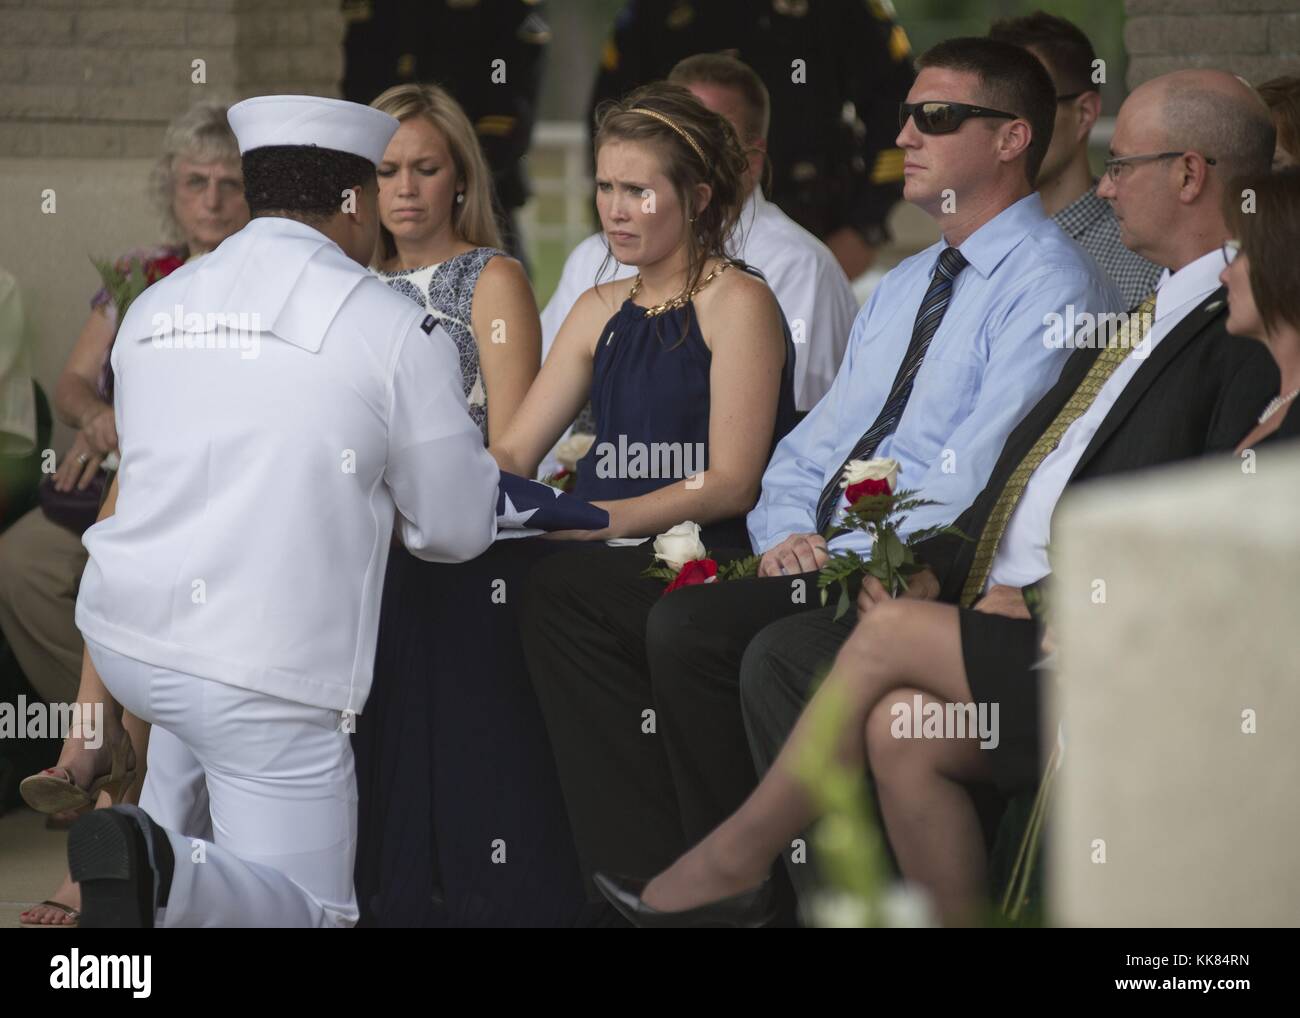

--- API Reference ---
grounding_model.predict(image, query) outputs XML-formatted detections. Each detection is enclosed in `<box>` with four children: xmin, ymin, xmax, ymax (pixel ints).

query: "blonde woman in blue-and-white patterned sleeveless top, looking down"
<box><xmin>371</xmin><ymin>85</ymin><xmax>542</xmax><ymax>443</ymax></box>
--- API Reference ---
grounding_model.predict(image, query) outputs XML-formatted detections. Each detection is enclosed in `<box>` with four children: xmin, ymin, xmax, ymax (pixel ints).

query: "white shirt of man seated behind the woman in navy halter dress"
<box><xmin>542</xmin><ymin>187</ymin><xmax>858</xmax><ymax>410</ymax></box>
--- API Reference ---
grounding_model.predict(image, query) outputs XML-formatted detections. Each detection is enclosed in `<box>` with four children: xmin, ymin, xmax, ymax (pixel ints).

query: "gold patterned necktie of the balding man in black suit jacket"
<box><xmin>962</xmin><ymin>294</ymin><xmax>1156</xmax><ymax>607</ymax></box>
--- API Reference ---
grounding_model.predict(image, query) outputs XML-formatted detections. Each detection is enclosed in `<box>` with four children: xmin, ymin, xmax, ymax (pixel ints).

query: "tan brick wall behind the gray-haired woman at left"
<box><xmin>0</xmin><ymin>0</ymin><xmax>343</xmax><ymax>434</ymax></box>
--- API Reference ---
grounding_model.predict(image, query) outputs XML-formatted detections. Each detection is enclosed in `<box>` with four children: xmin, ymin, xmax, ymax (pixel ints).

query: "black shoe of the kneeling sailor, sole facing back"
<box><xmin>68</xmin><ymin>806</ymin><xmax>176</xmax><ymax>930</ymax></box>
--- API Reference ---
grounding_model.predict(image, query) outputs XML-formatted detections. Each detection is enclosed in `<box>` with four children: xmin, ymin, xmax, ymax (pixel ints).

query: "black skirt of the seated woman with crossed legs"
<box><xmin>958</xmin><ymin>608</ymin><xmax>1043</xmax><ymax>798</ymax></box>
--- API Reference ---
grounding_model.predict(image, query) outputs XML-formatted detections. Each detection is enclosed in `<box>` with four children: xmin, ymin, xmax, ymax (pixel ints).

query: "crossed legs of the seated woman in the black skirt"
<box><xmin>642</xmin><ymin>599</ymin><xmax>989</xmax><ymax>923</ymax></box>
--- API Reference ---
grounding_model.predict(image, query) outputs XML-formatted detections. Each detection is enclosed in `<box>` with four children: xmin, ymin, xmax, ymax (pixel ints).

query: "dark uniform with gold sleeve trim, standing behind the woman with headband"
<box><xmin>592</xmin><ymin>0</ymin><xmax>915</xmax><ymax>247</ymax></box>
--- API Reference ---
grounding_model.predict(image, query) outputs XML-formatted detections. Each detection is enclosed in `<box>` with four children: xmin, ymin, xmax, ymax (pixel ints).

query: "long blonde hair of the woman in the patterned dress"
<box><xmin>371</xmin><ymin>82</ymin><xmax>502</xmax><ymax>257</ymax></box>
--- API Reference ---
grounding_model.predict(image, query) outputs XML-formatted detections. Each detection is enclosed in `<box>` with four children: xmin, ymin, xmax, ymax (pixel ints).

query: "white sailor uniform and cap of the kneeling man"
<box><xmin>69</xmin><ymin>96</ymin><xmax>499</xmax><ymax>926</ymax></box>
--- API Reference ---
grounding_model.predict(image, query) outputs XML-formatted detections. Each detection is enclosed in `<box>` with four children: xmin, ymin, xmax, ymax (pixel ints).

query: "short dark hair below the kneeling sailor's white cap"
<box><xmin>243</xmin><ymin>144</ymin><xmax>376</xmax><ymax>222</ymax></box>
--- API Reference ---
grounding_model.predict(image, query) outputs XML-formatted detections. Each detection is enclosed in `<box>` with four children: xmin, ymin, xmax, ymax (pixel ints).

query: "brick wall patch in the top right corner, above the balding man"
<box><xmin>1125</xmin><ymin>0</ymin><xmax>1300</xmax><ymax>88</ymax></box>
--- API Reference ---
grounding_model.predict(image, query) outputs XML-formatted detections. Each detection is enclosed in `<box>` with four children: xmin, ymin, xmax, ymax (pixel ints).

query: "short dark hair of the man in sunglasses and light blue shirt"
<box><xmin>917</xmin><ymin>36</ymin><xmax>1056</xmax><ymax>185</ymax></box>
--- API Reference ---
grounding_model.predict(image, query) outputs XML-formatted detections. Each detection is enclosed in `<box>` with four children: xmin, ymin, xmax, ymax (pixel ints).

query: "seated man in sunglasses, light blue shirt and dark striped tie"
<box><xmin>524</xmin><ymin>39</ymin><xmax>1122</xmax><ymax>910</ymax></box>
